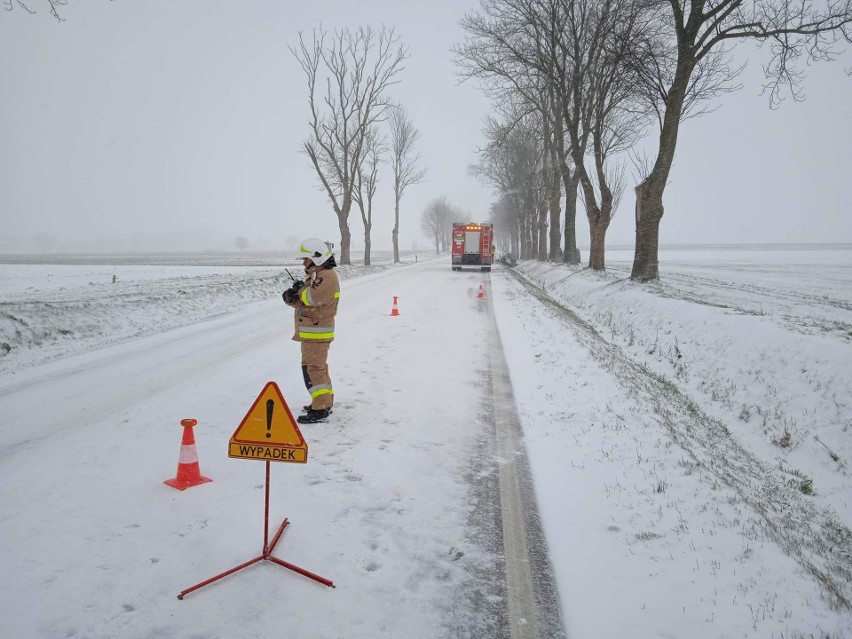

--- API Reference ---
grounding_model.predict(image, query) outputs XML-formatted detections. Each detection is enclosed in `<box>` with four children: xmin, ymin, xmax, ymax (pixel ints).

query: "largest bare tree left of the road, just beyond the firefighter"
<box><xmin>290</xmin><ymin>27</ymin><xmax>408</xmax><ymax>264</ymax></box>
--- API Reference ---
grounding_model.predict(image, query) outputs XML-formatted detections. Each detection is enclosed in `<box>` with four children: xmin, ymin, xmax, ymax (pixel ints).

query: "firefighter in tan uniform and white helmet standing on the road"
<box><xmin>282</xmin><ymin>238</ymin><xmax>340</xmax><ymax>424</ymax></box>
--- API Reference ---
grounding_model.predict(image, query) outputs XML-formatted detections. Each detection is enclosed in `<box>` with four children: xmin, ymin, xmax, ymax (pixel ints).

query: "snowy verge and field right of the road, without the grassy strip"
<box><xmin>492</xmin><ymin>253</ymin><xmax>852</xmax><ymax>639</ymax></box>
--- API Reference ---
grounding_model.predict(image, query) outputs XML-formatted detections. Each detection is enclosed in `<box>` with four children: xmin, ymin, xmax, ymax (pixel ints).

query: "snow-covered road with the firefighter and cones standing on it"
<box><xmin>0</xmin><ymin>261</ymin><xmax>561</xmax><ymax>638</ymax></box>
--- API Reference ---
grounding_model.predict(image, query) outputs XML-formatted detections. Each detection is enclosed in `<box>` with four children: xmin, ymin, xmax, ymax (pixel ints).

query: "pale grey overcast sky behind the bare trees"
<box><xmin>0</xmin><ymin>0</ymin><xmax>852</xmax><ymax>258</ymax></box>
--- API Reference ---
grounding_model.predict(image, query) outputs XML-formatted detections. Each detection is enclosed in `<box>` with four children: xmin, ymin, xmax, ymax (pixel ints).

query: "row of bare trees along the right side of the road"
<box><xmin>455</xmin><ymin>0</ymin><xmax>852</xmax><ymax>280</ymax></box>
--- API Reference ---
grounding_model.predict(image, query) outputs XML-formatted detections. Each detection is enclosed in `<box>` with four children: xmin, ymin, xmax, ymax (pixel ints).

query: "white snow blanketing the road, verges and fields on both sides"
<box><xmin>0</xmin><ymin>246</ymin><xmax>852</xmax><ymax>639</ymax></box>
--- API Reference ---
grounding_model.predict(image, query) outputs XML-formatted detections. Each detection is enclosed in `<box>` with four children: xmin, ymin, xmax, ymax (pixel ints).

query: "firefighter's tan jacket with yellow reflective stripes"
<box><xmin>288</xmin><ymin>266</ymin><xmax>340</xmax><ymax>343</ymax></box>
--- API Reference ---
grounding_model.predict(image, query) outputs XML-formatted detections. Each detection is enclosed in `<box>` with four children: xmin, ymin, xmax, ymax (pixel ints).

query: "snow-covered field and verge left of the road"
<box><xmin>0</xmin><ymin>256</ymin><xmax>408</xmax><ymax>372</ymax></box>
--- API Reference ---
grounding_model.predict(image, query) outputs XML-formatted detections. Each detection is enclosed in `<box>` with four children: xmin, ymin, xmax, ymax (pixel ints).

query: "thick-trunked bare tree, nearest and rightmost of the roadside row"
<box><xmin>631</xmin><ymin>0</ymin><xmax>852</xmax><ymax>281</ymax></box>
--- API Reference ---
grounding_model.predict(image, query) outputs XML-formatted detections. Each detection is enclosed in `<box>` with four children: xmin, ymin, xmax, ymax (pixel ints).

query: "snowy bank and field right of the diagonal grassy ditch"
<box><xmin>519</xmin><ymin>255</ymin><xmax>852</xmax><ymax>528</ymax></box>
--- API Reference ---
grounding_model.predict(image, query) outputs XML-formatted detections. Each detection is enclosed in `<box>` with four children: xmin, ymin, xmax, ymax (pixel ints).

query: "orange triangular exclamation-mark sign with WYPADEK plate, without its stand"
<box><xmin>228</xmin><ymin>382</ymin><xmax>308</xmax><ymax>463</ymax></box>
